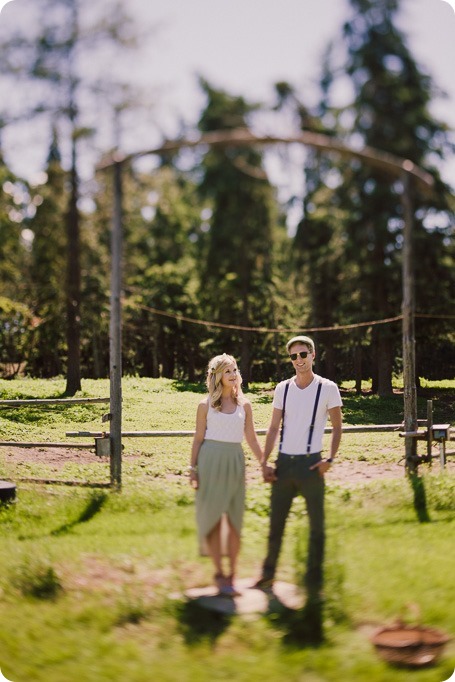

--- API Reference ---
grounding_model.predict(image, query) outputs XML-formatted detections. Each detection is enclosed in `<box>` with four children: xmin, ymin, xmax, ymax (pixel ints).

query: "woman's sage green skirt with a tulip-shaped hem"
<box><xmin>196</xmin><ymin>440</ymin><xmax>245</xmax><ymax>556</ymax></box>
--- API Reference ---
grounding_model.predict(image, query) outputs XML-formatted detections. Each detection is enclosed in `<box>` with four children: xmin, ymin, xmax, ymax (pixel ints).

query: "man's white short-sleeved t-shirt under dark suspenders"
<box><xmin>273</xmin><ymin>374</ymin><xmax>343</xmax><ymax>455</ymax></box>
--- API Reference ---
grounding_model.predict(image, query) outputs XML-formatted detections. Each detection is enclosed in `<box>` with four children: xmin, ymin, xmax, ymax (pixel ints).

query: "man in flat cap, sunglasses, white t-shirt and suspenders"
<box><xmin>255</xmin><ymin>336</ymin><xmax>342</xmax><ymax>593</ymax></box>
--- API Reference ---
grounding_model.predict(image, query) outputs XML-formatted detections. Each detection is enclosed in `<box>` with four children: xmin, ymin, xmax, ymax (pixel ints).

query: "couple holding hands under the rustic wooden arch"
<box><xmin>190</xmin><ymin>336</ymin><xmax>342</xmax><ymax>597</ymax></box>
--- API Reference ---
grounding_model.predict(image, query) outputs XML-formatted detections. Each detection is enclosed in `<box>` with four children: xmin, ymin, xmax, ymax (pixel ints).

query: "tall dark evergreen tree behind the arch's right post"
<box><xmin>278</xmin><ymin>0</ymin><xmax>453</xmax><ymax>395</ymax></box>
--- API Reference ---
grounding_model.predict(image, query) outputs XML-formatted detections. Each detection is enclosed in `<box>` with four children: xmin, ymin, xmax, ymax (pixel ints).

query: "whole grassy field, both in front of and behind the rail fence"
<box><xmin>0</xmin><ymin>378</ymin><xmax>455</xmax><ymax>682</ymax></box>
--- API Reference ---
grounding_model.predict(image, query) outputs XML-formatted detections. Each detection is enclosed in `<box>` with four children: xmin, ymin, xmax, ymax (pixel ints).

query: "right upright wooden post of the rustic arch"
<box><xmin>401</xmin><ymin>169</ymin><xmax>417</xmax><ymax>474</ymax></box>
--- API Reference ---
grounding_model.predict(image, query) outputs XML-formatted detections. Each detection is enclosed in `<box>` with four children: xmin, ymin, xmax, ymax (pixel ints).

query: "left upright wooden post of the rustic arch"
<box><xmin>109</xmin><ymin>161</ymin><xmax>122</xmax><ymax>488</ymax></box>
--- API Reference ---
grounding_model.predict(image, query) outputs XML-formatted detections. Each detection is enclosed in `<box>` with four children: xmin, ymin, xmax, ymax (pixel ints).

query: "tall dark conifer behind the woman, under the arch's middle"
<box><xmin>199</xmin><ymin>79</ymin><xmax>278</xmax><ymax>384</ymax></box>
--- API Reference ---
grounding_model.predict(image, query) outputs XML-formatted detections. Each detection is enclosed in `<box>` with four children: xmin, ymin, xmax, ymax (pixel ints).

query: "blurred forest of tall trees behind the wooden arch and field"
<box><xmin>0</xmin><ymin>0</ymin><xmax>455</xmax><ymax>395</ymax></box>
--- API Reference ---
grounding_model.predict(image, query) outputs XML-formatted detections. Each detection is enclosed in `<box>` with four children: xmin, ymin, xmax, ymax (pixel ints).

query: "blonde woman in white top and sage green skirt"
<box><xmin>190</xmin><ymin>353</ymin><xmax>262</xmax><ymax>596</ymax></box>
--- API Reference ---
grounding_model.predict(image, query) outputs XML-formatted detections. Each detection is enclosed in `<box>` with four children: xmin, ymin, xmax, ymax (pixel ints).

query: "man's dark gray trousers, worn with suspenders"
<box><xmin>262</xmin><ymin>452</ymin><xmax>325</xmax><ymax>589</ymax></box>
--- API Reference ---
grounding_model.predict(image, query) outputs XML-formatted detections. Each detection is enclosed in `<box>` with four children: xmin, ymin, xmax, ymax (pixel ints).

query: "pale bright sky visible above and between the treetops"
<box><xmin>0</xmin><ymin>0</ymin><xmax>455</xmax><ymax>197</ymax></box>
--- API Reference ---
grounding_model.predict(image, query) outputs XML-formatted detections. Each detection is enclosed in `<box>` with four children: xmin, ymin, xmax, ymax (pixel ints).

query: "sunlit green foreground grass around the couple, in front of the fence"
<box><xmin>0</xmin><ymin>476</ymin><xmax>455</xmax><ymax>682</ymax></box>
